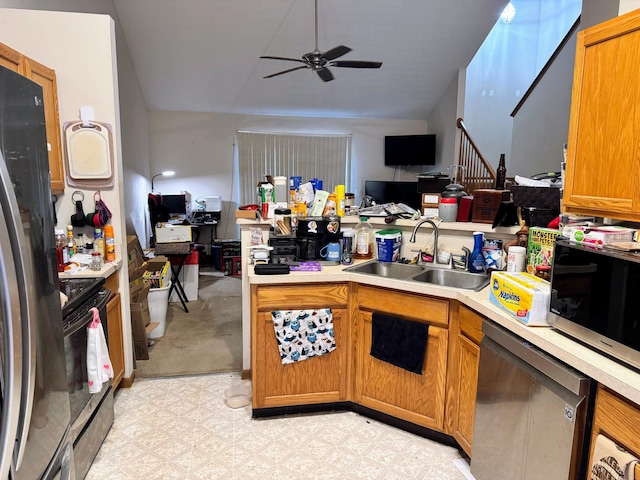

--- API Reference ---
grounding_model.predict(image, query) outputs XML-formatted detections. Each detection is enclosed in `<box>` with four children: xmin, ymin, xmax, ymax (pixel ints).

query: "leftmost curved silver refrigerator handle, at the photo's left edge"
<box><xmin>0</xmin><ymin>153</ymin><xmax>23</xmax><ymax>478</ymax></box>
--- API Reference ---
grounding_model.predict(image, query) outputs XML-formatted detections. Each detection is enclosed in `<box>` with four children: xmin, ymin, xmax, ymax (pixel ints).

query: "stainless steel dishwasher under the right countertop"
<box><xmin>471</xmin><ymin>320</ymin><xmax>591</xmax><ymax>480</ymax></box>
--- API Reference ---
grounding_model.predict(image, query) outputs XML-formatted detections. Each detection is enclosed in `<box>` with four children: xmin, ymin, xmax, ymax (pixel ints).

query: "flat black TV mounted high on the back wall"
<box><xmin>384</xmin><ymin>133</ymin><xmax>436</xmax><ymax>167</ymax></box>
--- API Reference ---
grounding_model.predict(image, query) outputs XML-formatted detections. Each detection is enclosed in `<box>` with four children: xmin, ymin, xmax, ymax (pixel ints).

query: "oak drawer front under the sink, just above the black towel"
<box><xmin>357</xmin><ymin>285</ymin><xmax>449</xmax><ymax>326</ymax></box>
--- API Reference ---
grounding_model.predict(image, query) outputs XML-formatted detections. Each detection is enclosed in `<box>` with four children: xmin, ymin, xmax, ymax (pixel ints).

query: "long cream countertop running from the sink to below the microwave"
<box><xmin>247</xmin><ymin>262</ymin><xmax>640</xmax><ymax>405</ymax></box>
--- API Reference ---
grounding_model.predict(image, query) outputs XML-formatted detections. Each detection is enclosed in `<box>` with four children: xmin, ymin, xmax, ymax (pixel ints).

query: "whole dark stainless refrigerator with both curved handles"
<box><xmin>0</xmin><ymin>66</ymin><xmax>75</xmax><ymax>480</ymax></box>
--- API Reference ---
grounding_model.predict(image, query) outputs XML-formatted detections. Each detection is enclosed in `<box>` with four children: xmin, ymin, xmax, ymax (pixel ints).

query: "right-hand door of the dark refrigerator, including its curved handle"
<box><xmin>0</xmin><ymin>67</ymin><xmax>70</xmax><ymax>479</ymax></box>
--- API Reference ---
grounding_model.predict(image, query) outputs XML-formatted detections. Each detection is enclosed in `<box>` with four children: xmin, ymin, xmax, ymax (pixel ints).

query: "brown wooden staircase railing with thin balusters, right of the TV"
<box><xmin>456</xmin><ymin>118</ymin><xmax>496</xmax><ymax>195</ymax></box>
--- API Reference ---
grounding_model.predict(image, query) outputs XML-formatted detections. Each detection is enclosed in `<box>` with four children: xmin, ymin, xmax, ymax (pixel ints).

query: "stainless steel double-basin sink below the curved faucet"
<box><xmin>345</xmin><ymin>260</ymin><xmax>490</xmax><ymax>292</ymax></box>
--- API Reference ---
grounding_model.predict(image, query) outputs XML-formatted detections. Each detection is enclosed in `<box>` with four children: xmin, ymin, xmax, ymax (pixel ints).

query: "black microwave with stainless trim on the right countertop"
<box><xmin>549</xmin><ymin>240</ymin><xmax>640</xmax><ymax>368</ymax></box>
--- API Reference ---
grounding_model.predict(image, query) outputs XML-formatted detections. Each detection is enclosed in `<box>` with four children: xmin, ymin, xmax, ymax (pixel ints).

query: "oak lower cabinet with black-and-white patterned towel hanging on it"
<box><xmin>251</xmin><ymin>283</ymin><xmax>351</xmax><ymax>409</ymax></box>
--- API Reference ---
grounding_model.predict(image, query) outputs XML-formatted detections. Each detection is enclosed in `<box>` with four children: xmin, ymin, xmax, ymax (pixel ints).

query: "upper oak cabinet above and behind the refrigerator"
<box><xmin>0</xmin><ymin>43</ymin><xmax>65</xmax><ymax>194</ymax></box>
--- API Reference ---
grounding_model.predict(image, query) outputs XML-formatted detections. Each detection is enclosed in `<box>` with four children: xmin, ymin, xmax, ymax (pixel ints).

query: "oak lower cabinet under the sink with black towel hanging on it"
<box><xmin>354</xmin><ymin>285</ymin><xmax>449</xmax><ymax>431</ymax></box>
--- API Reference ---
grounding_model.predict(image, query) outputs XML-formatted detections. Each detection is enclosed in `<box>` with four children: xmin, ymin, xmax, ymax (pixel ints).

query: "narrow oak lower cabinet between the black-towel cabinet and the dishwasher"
<box><xmin>446</xmin><ymin>302</ymin><xmax>483</xmax><ymax>456</ymax></box>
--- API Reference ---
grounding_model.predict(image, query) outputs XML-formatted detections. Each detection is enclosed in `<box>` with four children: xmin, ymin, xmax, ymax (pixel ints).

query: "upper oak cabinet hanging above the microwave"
<box><xmin>563</xmin><ymin>10</ymin><xmax>640</xmax><ymax>222</ymax></box>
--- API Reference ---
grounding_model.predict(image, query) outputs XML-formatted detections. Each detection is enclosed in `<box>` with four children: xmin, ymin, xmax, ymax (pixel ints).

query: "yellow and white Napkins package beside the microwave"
<box><xmin>489</xmin><ymin>272</ymin><xmax>551</xmax><ymax>326</ymax></box>
